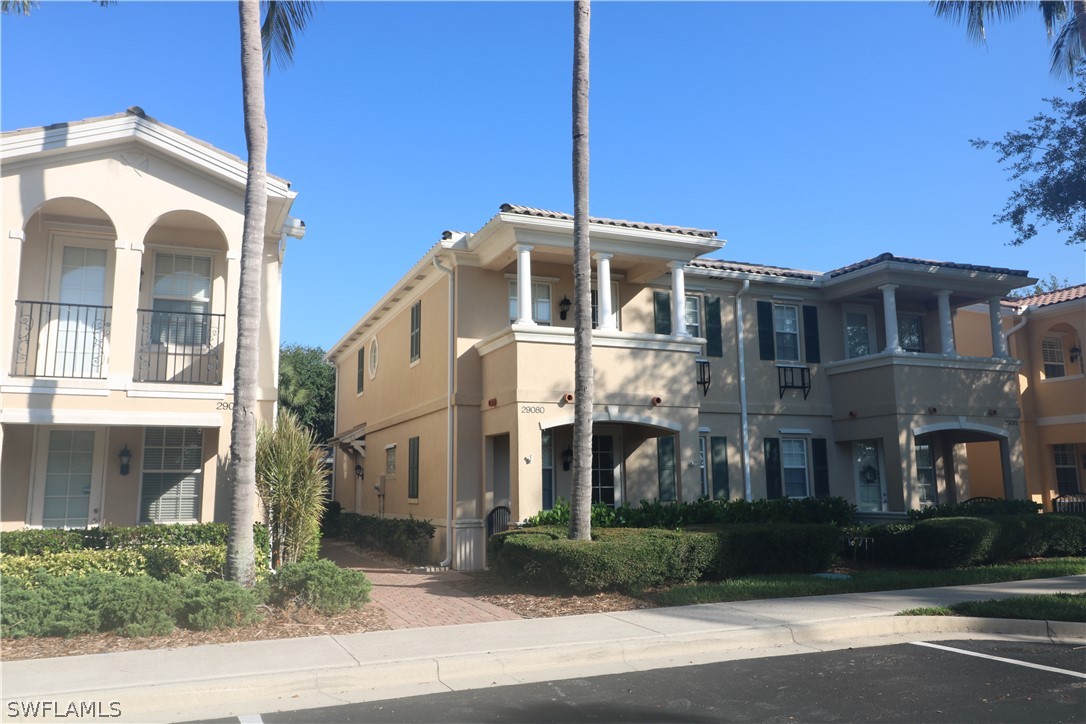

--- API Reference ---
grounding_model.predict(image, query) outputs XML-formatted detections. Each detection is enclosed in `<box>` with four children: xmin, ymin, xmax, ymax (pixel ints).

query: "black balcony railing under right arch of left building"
<box><xmin>135</xmin><ymin>309</ymin><xmax>226</xmax><ymax>384</ymax></box>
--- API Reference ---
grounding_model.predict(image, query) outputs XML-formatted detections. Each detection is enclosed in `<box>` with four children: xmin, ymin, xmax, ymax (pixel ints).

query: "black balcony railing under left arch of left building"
<box><xmin>12</xmin><ymin>300</ymin><xmax>112</xmax><ymax>380</ymax></box>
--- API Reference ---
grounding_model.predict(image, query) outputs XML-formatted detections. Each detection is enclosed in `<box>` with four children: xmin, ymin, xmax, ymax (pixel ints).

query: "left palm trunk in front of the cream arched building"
<box><xmin>226</xmin><ymin>0</ymin><xmax>268</xmax><ymax>586</ymax></box>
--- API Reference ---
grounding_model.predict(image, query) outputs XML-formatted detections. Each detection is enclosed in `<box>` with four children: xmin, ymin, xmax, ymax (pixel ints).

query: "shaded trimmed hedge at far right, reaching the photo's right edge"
<box><xmin>867</xmin><ymin>513</ymin><xmax>1086</xmax><ymax>568</ymax></box>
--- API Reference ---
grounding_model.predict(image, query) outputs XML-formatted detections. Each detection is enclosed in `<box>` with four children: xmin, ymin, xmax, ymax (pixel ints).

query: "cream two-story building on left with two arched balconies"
<box><xmin>0</xmin><ymin>107</ymin><xmax>304</xmax><ymax>530</ymax></box>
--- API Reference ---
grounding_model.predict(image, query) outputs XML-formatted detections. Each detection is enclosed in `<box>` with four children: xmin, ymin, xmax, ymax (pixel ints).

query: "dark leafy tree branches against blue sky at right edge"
<box><xmin>971</xmin><ymin>66</ymin><xmax>1086</xmax><ymax>246</ymax></box>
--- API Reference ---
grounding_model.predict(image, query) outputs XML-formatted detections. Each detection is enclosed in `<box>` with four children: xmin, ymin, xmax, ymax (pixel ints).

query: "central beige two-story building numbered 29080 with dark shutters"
<box><xmin>328</xmin><ymin>204</ymin><xmax>1032</xmax><ymax>569</ymax></box>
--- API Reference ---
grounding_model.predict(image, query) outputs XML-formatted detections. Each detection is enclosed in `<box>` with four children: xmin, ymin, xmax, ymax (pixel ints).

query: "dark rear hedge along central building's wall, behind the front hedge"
<box><xmin>526</xmin><ymin>497</ymin><xmax>856</xmax><ymax>530</ymax></box>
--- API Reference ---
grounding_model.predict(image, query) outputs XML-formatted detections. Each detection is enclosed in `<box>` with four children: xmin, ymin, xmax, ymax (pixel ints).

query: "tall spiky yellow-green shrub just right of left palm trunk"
<box><xmin>256</xmin><ymin>410</ymin><xmax>328</xmax><ymax>568</ymax></box>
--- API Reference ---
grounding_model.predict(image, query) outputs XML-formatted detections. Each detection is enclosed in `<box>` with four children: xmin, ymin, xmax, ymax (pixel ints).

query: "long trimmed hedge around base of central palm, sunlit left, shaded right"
<box><xmin>490</xmin><ymin>524</ymin><xmax>841</xmax><ymax>593</ymax></box>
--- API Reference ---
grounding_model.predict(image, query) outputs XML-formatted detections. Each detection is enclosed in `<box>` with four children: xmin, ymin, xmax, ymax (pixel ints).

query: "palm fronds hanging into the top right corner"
<box><xmin>931</xmin><ymin>0</ymin><xmax>1086</xmax><ymax>77</ymax></box>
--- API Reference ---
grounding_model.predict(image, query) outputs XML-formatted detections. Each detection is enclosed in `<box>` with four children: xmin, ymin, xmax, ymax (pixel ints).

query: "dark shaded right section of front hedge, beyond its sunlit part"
<box><xmin>710</xmin><ymin>523</ymin><xmax>841</xmax><ymax>577</ymax></box>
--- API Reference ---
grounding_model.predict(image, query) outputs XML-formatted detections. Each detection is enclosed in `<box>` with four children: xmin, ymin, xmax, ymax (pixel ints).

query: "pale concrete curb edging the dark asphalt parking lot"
<box><xmin>3</xmin><ymin>615</ymin><xmax>1086</xmax><ymax>722</ymax></box>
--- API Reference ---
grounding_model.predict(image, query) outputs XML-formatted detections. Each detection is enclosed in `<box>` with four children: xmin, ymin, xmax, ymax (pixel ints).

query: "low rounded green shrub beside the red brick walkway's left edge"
<box><xmin>267</xmin><ymin>560</ymin><xmax>372</xmax><ymax>615</ymax></box>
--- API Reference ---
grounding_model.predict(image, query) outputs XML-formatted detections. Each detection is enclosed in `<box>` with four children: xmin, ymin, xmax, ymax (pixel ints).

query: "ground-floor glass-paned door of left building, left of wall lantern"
<box><xmin>33</xmin><ymin>428</ymin><xmax>105</xmax><ymax>528</ymax></box>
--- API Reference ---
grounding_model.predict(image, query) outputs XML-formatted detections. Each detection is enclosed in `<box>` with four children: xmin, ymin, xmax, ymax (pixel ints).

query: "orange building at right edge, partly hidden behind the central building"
<box><xmin>956</xmin><ymin>284</ymin><xmax>1086</xmax><ymax>510</ymax></box>
